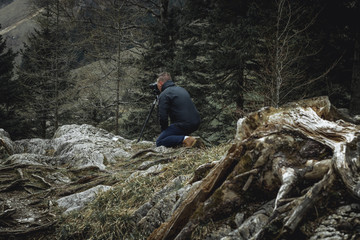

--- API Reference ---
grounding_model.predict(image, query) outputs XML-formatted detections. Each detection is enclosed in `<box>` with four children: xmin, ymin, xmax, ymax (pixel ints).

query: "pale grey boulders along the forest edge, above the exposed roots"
<box><xmin>1</xmin><ymin>124</ymin><xmax>146</xmax><ymax>170</ymax></box>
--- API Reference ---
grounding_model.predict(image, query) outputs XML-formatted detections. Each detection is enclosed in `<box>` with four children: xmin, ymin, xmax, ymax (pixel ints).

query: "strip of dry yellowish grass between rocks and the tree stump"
<box><xmin>57</xmin><ymin>144</ymin><xmax>229</xmax><ymax>240</ymax></box>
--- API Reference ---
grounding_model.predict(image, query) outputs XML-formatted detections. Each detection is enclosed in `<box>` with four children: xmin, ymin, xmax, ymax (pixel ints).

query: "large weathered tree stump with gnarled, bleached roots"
<box><xmin>148</xmin><ymin>97</ymin><xmax>360</xmax><ymax>240</ymax></box>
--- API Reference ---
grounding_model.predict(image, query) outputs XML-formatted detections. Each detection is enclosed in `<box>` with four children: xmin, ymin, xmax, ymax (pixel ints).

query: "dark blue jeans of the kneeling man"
<box><xmin>156</xmin><ymin>124</ymin><xmax>186</xmax><ymax>147</ymax></box>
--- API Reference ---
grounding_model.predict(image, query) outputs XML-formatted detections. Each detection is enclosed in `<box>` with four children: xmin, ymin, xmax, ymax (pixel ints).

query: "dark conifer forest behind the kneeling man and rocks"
<box><xmin>0</xmin><ymin>0</ymin><xmax>360</xmax><ymax>144</ymax></box>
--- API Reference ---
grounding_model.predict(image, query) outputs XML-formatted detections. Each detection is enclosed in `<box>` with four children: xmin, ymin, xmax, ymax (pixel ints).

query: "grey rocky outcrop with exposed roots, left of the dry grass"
<box><xmin>0</xmin><ymin>125</ymin><xmax>157</xmax><ymax>239</ymax></box>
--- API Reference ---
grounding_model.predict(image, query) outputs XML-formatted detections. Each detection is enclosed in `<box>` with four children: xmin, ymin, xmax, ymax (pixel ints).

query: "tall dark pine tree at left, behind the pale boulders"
<box><xmin>19</xmin><ymin>0</ymin><xmax>74</xmax><ymax>138</ymax></box>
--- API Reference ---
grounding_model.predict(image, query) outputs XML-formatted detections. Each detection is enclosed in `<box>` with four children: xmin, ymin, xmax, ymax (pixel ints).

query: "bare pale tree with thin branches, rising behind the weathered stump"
<box><xmin>260</xmin><ymin>0</ymin><xmax>322</xmax><ymax>107</ymax></box>
